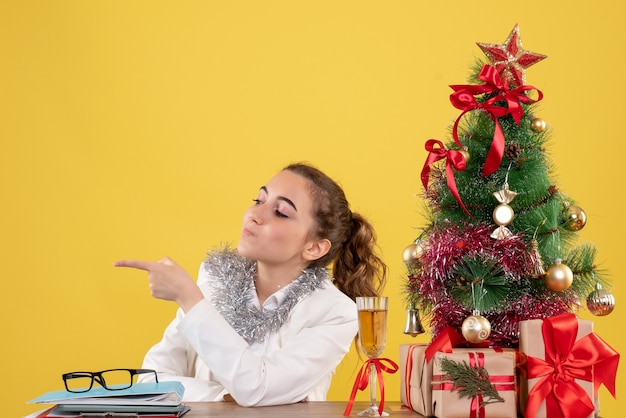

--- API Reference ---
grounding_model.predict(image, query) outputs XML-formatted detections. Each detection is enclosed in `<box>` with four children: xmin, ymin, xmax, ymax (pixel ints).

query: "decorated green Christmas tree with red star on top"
<box><xmin>403</xmin><ymin>25</ymin><xmax>614</xmax><ymax>347</ymax></box>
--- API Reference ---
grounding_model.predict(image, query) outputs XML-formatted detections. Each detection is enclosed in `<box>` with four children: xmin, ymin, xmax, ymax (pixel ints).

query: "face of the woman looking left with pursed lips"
<box><xmin>237</xmin><ymin>170</ymin><xmax>317</xmax><ymax>265</ymax></box>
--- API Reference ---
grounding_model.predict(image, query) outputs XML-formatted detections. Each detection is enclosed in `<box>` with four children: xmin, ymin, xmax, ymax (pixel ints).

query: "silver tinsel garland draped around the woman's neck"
<box><xmin>203</xmin><ymin>248</ymin><xmax>328</xmax><ymax>344</ymax></box>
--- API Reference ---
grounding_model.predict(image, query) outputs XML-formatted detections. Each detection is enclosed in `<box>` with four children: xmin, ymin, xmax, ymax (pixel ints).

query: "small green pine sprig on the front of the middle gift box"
<box><xmin>441</xmin><ymin>357</ymin><xmax>504</xmax><ymax>406</ymax></box>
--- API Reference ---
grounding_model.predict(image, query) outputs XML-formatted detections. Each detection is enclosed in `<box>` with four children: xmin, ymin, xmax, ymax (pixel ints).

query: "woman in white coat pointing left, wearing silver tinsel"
<box><xmin>115</xmin><ymin>164</ymin><xmax>386</xmax><ymax>406</ymax></box>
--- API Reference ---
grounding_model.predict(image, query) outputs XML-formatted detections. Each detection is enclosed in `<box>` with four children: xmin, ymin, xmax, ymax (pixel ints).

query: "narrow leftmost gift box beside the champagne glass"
<box><xmin>400</xmin><ymin>344</ymin><xmax>433</xmax><ymax>417</ymax></box>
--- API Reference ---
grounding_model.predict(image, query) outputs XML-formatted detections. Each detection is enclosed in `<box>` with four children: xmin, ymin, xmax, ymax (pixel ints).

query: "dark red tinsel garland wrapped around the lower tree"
<box><xmin>408</xmin><ymin>223</ymin><xmax>574</xmax><ymax>347</ymax></box>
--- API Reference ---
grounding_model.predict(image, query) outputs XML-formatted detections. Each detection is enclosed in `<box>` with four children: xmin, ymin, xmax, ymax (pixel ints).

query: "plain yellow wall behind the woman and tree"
<box><xmin>0</xmin><ymin>0</ymin><xmax>626</xmax><ymax>417</ymax></box>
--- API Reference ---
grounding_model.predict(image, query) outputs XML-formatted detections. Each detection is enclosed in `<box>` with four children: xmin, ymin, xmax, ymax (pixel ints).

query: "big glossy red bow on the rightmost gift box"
<box><xmin>524</xmin><ymin>314</ymin><xmax>619</xmax><ymax>418</ymax></box>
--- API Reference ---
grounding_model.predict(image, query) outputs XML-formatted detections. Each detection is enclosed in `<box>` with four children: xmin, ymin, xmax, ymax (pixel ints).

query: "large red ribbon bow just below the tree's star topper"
<box><xmin>450</xmin><ymin>65</ymin><xmax>543</xmax><ymax>177</ymax></box>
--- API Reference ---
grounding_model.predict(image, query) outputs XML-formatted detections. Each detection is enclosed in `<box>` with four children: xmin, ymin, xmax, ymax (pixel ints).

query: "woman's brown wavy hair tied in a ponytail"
<box><xmin>284</xmin><ymin>163</ymin><xmax>387</xmax><ymax>299</ymax></box>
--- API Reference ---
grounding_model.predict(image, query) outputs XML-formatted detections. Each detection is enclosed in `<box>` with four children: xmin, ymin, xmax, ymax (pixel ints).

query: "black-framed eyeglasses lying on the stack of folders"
<box><xmin>63</xmin><ymin>369</ymin><xmax>159</xmax><ymax>393</ymax></box>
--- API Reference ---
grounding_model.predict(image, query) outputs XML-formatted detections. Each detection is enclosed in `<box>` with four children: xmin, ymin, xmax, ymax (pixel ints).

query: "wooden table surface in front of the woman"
<box><xmin>183</xmin><ymin>401</ymin><xmax>421</xmax><ymax>418</ymax></box>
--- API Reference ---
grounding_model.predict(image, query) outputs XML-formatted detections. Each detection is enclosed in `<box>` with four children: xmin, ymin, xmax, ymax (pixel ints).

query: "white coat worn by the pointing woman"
<box><xmin>143</xmin><ymin>264</ymin><xmax>358</xmax><ymax>406</ymax></box>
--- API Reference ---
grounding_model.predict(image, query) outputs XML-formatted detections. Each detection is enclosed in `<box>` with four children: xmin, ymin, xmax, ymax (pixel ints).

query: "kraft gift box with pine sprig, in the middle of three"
<box><xmin>432</xmin><ymin>348</ymin><xmax>518</xmax><ymax>418</ymax></box>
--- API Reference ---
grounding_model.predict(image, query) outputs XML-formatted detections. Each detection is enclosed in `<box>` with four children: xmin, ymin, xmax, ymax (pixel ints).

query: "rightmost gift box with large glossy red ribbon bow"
<box><xmin>519</xmin><ymin>314</ymin><xmax>619</xmax><ymax>418</ymax></box>
